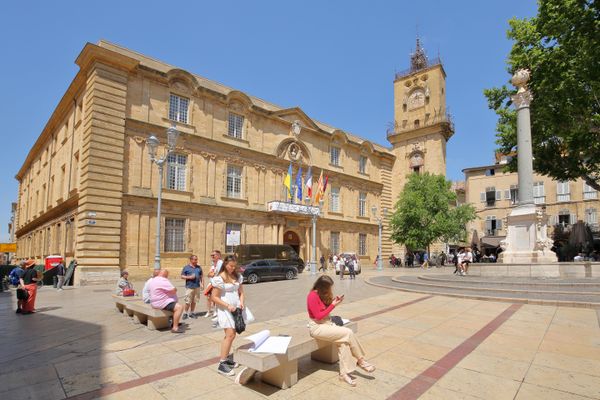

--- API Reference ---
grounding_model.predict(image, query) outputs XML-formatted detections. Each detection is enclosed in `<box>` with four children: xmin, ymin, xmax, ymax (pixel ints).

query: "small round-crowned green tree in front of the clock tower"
<box><xmin>390</xmin><ymin>173</ymin><xmax>475</xmax><ymax>253</ymax></box>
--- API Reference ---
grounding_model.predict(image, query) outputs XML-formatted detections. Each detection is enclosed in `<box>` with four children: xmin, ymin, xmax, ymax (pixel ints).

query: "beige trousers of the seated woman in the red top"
<box><xmin>308</xmin><ymin>321</ymin><xmax>365</xmax><ymax>374</ymax></box>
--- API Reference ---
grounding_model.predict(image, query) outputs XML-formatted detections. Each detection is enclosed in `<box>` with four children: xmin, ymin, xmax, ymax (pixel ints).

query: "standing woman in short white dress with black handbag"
<box><xmin>211</xmin><ymin>256</ymin><xmax>244</xmax><ymax>375</ymax></box>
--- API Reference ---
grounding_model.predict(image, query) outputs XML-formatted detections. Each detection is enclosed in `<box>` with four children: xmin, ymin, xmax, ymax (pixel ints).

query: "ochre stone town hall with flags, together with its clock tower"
<box><xmin>15</xmin><ymin>41</ymin><xmax>452</xmax><ymax>284</ymax></box>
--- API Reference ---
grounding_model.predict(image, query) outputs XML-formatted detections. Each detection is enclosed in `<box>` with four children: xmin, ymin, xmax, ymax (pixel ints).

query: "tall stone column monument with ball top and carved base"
<box><xmin>498</xmin><ymin>69</ymin><xmax>558</xmax><ymax>264</ymax></box>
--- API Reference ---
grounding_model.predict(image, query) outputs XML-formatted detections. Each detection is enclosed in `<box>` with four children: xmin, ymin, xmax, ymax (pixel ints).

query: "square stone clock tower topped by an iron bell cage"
<box><xmin>387</xmin><ymin>38</ymin><xmax>454</xmax><ymax>254</ymax></box>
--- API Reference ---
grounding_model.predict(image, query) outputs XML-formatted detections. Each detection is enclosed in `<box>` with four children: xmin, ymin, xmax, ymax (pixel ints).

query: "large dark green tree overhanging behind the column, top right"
<box><xmin>484</xmin><ymin>0</ymin><xmax>600</xmax><ymax>190</ymax></box>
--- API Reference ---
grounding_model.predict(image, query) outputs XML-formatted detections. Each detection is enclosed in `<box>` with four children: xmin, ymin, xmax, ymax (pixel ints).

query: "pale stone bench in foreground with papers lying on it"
<box><xmin>234</xmin><ymin>322</ymin><xmax>358</xmax><ymax>389</ymax></box>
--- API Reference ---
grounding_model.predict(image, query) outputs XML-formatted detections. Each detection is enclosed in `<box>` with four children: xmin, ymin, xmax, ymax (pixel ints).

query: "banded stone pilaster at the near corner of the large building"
<box><xmin>75</xmin><ymin>62</ymin><xmax>127</xmax><ymax>284</ymax></box>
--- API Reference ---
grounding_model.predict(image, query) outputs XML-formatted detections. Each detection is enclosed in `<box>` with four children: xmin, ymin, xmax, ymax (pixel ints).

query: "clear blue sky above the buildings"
<box><xmin>0</xmin><ymin>0</ymin><xmax>537</xmax><ymax>242</ymax></box>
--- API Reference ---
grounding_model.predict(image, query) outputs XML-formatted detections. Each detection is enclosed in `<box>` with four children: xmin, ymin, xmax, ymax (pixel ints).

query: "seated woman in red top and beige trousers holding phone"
<box><xmin>306</xmin><ymin>275</ymin><xmax>375</xmax><ymax>386</ymax></box>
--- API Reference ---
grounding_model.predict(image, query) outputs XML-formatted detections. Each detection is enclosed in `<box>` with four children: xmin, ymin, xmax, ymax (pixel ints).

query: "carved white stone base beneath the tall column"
<box><xmin>498</xmin><ymin>204</ymin><xmax>558</xmax><ymax>264</ymax></box>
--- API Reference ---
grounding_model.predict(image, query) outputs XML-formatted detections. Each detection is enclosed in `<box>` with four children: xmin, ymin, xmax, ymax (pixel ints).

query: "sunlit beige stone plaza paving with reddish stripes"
<box><xmin>0</xmin><ymin>267</ymin><xmax>600</xmax><ymax>400</ymax></box>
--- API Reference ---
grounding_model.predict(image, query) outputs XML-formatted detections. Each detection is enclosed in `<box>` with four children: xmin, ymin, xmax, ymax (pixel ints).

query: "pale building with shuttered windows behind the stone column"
<box><xmin>463</xmin><ymin>156</ymin><xmax>600</xmax><ymax>251</ymax></box>
